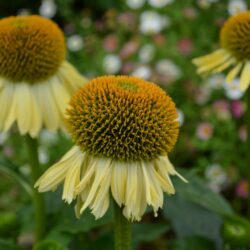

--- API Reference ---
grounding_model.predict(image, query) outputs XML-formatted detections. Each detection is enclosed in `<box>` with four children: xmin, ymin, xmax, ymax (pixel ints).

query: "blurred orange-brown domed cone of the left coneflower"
<box><xmin>0</xmin><ymin>16</ymin><xmax>65</xmax><ymax>83</ymax></box>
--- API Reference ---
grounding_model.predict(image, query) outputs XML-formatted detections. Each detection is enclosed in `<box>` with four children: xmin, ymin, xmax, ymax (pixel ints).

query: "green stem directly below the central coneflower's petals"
<box><xmin>114</xmin><ymin>201</ymin><xmax>131</xmax><ymax>250</ymax></box>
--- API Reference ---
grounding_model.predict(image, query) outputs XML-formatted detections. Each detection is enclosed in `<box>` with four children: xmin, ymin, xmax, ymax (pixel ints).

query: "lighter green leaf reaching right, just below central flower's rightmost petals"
<box><xmin>175</xmin><ymin>173</ymin><xmax>233</xmax><ymax>215</ymax></box>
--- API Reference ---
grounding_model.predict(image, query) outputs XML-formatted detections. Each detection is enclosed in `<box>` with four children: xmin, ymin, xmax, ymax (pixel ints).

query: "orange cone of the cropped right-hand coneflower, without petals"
<box><xmin>220</xmin><ymin>11</ymin><xmax>250</xmax><ymax>60</ymax></box>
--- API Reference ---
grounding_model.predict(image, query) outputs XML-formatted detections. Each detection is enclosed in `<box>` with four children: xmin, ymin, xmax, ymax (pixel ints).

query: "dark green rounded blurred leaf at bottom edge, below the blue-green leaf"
<box><xmin>173</xmin><ymin>236</ymin><xmax>215</xmax><ymax>250</ymax></box>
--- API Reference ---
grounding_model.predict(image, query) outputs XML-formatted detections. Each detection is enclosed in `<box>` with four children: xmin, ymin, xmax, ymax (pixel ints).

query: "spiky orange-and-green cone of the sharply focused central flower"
<box><xmin>67</xmin><ymin>76</ymin><xmax>179</xmax><ymax>161</ymax></box>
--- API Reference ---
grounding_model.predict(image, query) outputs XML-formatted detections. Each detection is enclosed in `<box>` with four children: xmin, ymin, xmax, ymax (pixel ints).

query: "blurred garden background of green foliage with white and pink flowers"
<box><xmin>0</xmin><ymin>0</ymin><xmax>250</xmax><ymax>250</ymax></box>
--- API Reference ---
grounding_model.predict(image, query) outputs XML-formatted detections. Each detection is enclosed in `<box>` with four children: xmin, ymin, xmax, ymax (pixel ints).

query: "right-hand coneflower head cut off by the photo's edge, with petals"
<box><xmin>193</xmin><ymin>11</ymin><xmax>250</xmax><ymax>91</ymax></box>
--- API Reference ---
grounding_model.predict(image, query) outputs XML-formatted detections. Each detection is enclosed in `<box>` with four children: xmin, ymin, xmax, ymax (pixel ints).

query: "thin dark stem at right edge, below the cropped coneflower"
<box><xmin>246</xmin><ymin>88</ymin><xmax>250</xmax><ymax>216</ymax></box>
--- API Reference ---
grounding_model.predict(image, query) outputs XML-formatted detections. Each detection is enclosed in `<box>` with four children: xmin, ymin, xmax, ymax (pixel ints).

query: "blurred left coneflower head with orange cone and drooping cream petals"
<box><xmin>0</xmin><ymin>16</ymin><xmax>86</xmax><ymax>137</ymax></box>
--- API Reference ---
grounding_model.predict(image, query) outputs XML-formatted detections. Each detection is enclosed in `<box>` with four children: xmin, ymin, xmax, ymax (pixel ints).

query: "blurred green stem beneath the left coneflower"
<box><xmin>25</xmin><ymin>135</ymin><xmax>46</xmax><ymax>241</ymax></box>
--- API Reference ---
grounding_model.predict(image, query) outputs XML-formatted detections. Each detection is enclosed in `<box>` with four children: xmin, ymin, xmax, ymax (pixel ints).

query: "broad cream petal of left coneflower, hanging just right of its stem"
<box><xmin>33</xmin><ymin>82</ymin><xmax>61</xmax><ymax>131</ymax></box>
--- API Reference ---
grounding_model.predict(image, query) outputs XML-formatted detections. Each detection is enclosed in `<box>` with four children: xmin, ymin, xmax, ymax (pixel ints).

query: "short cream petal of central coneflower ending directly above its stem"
<box><xmin>111</xmin><ymin>162</ymin><xmax>128</xmax><ymax>206</ymax></box>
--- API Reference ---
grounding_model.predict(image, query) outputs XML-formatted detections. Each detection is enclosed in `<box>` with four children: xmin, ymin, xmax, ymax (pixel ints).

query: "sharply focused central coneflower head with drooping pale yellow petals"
<box><xmin>35</xmin><ymin>76</ymin><xmax>185</xmax><ymax>221</ymax></box>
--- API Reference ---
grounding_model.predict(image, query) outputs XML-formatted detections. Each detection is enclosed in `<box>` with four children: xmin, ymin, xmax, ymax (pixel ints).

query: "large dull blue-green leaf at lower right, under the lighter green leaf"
<box><xmin>163</xmin><ymin>194</ymin><xmax>222</xmax><ymax>246</ymax></box>
